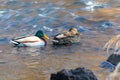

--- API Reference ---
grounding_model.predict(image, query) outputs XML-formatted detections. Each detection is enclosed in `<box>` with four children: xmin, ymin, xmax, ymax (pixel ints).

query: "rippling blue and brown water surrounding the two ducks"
<box><xmin>0</xmin><ymin>0</ymin><xmax>120</xmax><ymax>80</ymax></box>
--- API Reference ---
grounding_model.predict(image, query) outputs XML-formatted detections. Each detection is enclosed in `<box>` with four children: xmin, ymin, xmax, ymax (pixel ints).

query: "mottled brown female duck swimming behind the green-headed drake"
<box><xmin>52</xmin><ymin>28</ymin><xmax>80</xmax><ymax>45</ymax></box>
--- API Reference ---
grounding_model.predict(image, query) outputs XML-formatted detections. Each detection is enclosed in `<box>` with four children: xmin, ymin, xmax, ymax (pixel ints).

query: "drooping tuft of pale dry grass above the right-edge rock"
<box><xmin>103</xmin><ymin>35</ymin><xmax>120</xmax><ymax>53</ymax></box>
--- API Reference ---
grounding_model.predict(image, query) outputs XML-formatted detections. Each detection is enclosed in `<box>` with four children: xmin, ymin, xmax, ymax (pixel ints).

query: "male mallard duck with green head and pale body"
<box><xmin>11</xmin><ymin>30</ymin><xmax>49</xmax><ymax>47</ymax></box>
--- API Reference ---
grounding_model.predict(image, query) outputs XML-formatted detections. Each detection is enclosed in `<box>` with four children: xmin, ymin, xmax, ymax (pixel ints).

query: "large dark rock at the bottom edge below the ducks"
<box><xmin>50</xmin><ymin>67</ymin><xmax>98</xmax><ymax>80</ymax></box>
